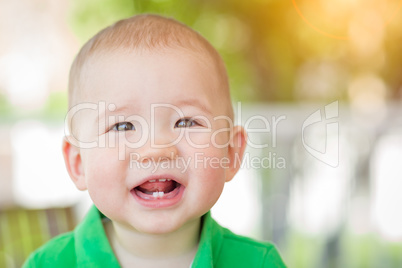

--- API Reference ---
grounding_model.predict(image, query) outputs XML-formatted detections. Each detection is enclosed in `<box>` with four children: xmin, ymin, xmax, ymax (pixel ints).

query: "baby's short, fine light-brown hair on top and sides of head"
<box><xmin>68</xmin><ymin>14</ymin><xmax>233</xmax><ymax>121</ymax></box>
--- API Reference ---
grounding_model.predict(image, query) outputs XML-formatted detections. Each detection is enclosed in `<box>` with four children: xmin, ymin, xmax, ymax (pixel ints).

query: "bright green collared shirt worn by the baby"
<box><xmin>23</xmin><ymin>206</ymin><xmax>286</xmax><ymax>268</ymax></box>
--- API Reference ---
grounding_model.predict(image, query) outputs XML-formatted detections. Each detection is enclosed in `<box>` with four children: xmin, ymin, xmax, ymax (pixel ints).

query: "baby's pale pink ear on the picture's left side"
<box><xmin>63</xmin><ymin>137</ymin><xmax>87</xmax><ymax>191</ymax></box>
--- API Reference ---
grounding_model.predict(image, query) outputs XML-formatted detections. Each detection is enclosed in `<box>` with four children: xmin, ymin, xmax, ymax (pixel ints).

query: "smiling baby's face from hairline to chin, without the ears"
<box><xmin>71</xmin><ymin>49</ymin><xmax>234</xmax><ymax>233</ymax></box>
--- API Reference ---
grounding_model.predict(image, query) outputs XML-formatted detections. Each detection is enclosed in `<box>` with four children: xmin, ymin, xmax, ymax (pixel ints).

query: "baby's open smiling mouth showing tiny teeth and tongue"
<box><xmin>132</xmin><ymin>179</ymin><xmax>182</xmax><ymax>200</ymax></box>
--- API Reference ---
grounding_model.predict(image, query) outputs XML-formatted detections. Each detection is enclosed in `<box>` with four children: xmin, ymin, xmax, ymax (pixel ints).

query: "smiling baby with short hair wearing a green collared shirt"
<box><xmin>24</xmin><ymin>15</ymin><xmax>285</xmax><ymax>268</ymax></box>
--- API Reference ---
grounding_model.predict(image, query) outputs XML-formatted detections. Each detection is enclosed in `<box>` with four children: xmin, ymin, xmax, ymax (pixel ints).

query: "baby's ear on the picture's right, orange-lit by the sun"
<box><xmin>226</xmin><ymin>126</ymin><xmax>247</xmax><ymax>182</ymax></box>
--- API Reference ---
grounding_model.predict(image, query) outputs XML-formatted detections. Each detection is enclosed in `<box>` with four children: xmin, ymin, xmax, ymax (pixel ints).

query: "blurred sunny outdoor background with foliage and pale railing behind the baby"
<box><xmin>0</xmin><ymin>0</ymin><xmax>402</xmax><ymax>268</ymax></box>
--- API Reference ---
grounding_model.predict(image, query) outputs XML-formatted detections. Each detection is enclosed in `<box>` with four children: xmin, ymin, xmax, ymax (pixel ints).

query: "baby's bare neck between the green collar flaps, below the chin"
<box><xmin>105</xmin><ymin>219</ymin><xmax>201</xmax><ymax>268</ymax></box>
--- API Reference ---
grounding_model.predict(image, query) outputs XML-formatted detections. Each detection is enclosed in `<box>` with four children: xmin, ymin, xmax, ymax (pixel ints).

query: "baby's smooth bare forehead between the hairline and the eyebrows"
<box><xmin>73</xmin><ymin>49</ymin><xmax>230</xmax><ymax>120</ymax></box>
